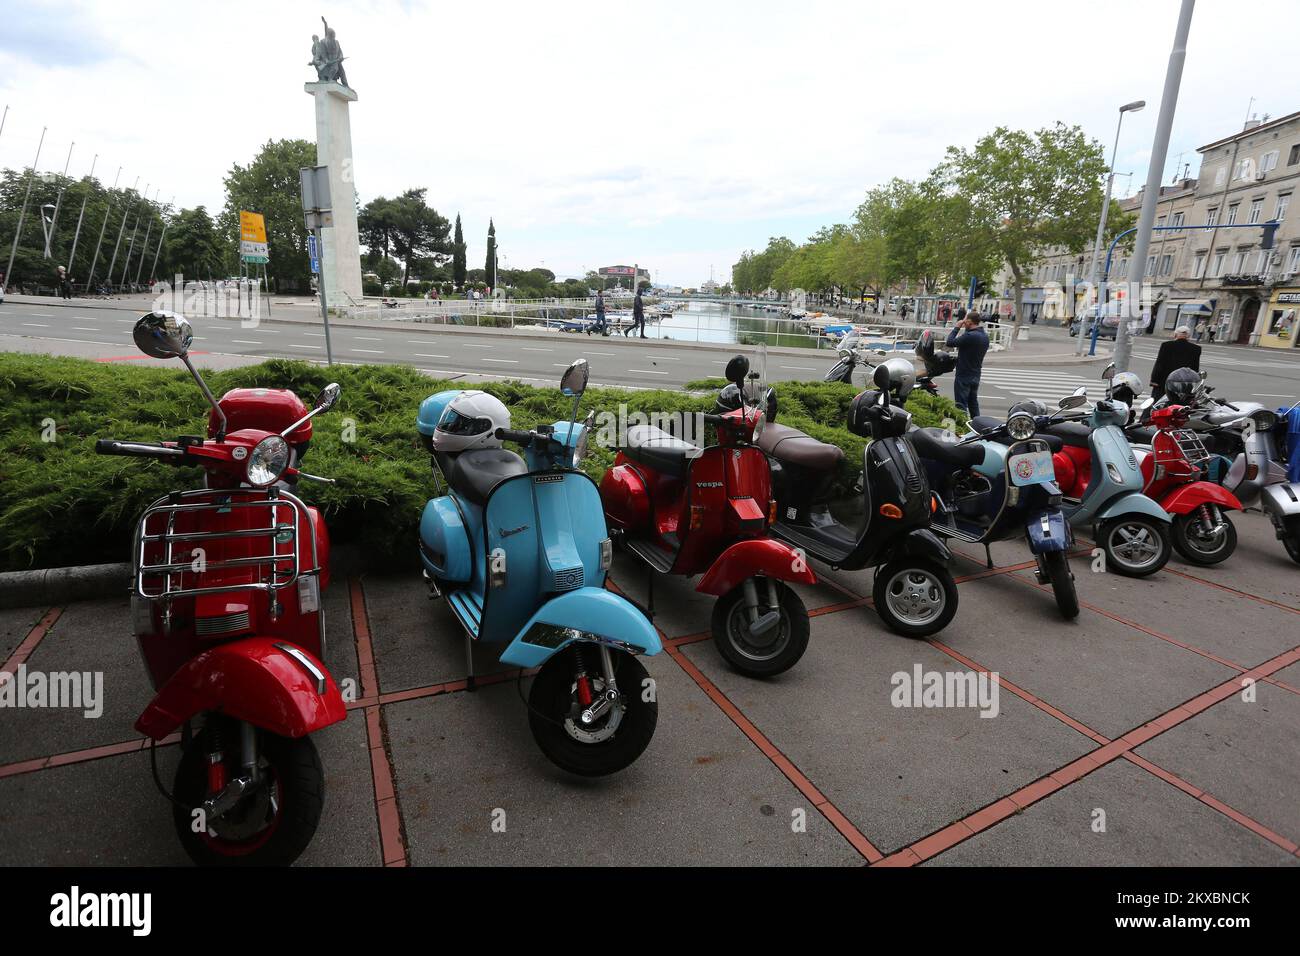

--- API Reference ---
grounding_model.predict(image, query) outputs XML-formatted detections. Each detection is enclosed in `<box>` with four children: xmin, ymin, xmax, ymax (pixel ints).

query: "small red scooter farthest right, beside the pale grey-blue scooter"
<box><xmin>1134</xmin><ymin>398</ymin><xmax>1242</xmax><ymax>564</ymax></box>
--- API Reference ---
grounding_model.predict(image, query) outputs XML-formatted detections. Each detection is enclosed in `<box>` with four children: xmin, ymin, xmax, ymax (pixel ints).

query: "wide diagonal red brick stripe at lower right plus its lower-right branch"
<box><xmin>878</xmin><ymin>646</ymin><xmax>1300</xmax><ymax>866</ymax></box>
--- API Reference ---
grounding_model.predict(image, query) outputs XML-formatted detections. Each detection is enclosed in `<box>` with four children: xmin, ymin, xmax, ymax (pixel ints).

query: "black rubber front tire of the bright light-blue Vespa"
<box><xmin>528</xmin><ymin>650</ymin><xmax>659</xmax><ymax>777</ymax></box>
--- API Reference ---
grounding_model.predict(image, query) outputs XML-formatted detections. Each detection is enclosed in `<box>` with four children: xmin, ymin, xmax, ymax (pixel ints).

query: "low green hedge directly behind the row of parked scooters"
<box><xmin>0</xmin><ymin>352</ymin><xmax>956</xmax><ymax>571</ymax></box>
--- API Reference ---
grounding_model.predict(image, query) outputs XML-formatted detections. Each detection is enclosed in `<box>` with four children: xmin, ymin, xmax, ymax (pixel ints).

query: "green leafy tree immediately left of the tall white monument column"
<box><xmin>217</xmin><ymin>139</ymin><xmax>316</xmax><ymax>290</ymax></box>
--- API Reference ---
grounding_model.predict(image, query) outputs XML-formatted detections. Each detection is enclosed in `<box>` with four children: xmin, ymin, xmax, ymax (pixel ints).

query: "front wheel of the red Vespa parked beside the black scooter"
<box><xmin>712</xmin><ymin>579</ymin><xmax>810</xmax><ymax>678</ymax></box>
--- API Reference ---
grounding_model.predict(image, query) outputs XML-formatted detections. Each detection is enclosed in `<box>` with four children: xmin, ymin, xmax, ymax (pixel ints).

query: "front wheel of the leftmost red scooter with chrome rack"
<box><xmin>172</xmin><ymin>717</ymin><xmax>325</xmax><ymax>866</ymax></box>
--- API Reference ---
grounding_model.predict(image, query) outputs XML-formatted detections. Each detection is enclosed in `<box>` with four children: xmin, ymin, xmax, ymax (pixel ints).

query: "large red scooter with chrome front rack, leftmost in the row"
<box><xmin>95</xmin><ymin>312</ymin><xmax>346</xmax><ymax>866</ymax></box>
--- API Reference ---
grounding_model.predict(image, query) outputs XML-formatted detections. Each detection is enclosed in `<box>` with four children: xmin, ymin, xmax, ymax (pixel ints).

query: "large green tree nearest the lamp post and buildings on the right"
<box><xmin>935</xmin><ymin>122</ymin><xmax>1106</xmax><ymax>347</ymax></box>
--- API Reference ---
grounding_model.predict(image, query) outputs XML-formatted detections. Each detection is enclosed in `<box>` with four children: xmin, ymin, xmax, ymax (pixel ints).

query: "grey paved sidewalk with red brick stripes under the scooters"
<box><xmin>0</xmin><ymin>515</ymin><xmax>1300</xmax><ymax>865</ymax></box>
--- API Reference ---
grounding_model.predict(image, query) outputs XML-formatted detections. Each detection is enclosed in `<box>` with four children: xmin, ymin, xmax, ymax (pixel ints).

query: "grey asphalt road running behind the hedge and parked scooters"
<box><xmin>0</xmin><ymin>300</ymin><xmax>1300</xmax><ymax>414</ymax></box>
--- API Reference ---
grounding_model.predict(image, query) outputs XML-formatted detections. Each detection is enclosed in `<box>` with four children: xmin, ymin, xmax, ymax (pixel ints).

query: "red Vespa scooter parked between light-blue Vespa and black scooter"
<box><xmin>601</xmin><ymin>355</ymin><xmax>816</xmax><ymax>678</ymax></box>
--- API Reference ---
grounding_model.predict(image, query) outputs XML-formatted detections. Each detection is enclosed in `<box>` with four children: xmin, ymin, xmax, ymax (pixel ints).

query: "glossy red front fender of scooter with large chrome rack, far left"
<box><xmin>135</xmin><ymin>637</ymin><xmax>347</xmax><ymax>740</ymax></box>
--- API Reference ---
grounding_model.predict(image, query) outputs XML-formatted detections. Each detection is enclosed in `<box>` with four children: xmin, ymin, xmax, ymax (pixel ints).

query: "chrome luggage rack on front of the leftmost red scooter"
<box><xmin>131</xmin><ymin>488</ymin><xmax>321</xmax><ymax>614</ymax></box>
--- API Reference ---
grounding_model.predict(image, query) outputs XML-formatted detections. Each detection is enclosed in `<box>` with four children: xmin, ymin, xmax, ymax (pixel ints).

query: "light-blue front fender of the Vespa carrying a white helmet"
<box><xmin>501</xmin><ymin>588</ymin><xmax>663</xmax><ymax>667</ymax></box>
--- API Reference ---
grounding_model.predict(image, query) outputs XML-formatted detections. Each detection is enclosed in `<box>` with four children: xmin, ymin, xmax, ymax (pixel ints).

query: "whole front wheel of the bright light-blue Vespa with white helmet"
<box><xmin>528</xmin><ymin>644</ymin><xmax>659</xmax><ymax>777</ymax></box>
